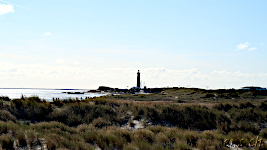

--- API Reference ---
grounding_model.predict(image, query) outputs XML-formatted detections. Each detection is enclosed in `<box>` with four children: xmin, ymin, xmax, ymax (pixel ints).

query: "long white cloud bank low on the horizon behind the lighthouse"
<box><xmin>0</xmin><ymin>59</ymin><xmax>267</xmax><ymax>89</ymax></box>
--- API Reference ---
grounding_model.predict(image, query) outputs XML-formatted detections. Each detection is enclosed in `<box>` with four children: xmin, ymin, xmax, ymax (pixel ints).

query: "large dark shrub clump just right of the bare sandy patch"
<box><xmin>151</xmin><ymin>106</ymin><xmax>224</xmax><ymax>130</ymax></box>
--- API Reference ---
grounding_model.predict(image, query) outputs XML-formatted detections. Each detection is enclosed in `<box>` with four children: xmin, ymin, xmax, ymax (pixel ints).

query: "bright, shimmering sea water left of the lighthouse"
<box><xmin>0</xmin><ymin>89</ymin><xmax>105</xmax><ymax>101</ymax></box>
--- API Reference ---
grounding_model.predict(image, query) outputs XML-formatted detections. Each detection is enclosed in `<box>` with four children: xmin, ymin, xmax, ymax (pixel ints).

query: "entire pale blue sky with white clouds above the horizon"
<box><xmin>0</xmin><ymin>0</ymin><xmax>267</xmax><ymax>89</ymax></box>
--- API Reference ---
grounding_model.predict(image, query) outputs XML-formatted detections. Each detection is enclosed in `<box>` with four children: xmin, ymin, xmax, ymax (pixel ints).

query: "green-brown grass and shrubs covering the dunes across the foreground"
<box><xmin>0</xmin><ymin>89</ymin><xmax>267</xmax><ymax>150</ymax></box>
